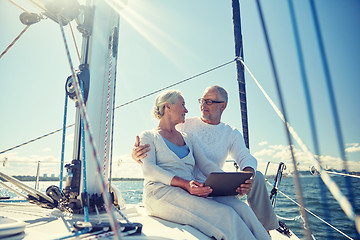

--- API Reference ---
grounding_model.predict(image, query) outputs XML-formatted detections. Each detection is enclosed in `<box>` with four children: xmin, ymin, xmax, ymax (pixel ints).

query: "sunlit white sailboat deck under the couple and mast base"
<box><xmin>0</xmin><ymin>202</ymin><xmax>298</xmax><ymax>240</ymax></box>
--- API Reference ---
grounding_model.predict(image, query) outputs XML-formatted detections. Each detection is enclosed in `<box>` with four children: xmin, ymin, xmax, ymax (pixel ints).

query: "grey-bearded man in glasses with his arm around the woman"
<box><xmin>132</xmin><ymin>86</ymin><xmax>279</xmax><ymax>231</ymax></box>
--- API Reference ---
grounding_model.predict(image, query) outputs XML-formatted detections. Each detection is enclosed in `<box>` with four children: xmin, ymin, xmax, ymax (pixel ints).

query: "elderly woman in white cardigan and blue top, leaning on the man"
<box><xmin>140</xmin><ymin>90</ymin><xmax>270</xmax><ymax>239</ymax></box>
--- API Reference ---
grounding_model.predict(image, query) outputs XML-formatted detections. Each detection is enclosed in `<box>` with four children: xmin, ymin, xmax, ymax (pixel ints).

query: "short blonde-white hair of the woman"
<box><xmin>153</xmin><ymin>90</ymin><xmax>182</xmax><ymax>119</ymax></box>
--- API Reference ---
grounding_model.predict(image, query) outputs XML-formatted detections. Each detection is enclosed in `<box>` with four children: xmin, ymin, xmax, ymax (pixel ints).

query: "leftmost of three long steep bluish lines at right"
<box><xmin>256</xmin><ymin>0</ymin><xmax>311</xmax><ymax>239</ymax></box>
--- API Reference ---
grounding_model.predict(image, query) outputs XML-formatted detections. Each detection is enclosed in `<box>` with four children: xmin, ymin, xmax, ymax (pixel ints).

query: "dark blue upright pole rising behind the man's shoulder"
<box><xmin>232</xmin><ymin>0</ymin><xmax>249</xmax><ymax>149</ymax></box>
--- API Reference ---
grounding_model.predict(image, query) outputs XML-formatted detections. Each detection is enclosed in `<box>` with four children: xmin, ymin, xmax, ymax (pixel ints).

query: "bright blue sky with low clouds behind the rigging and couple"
<box><xmin>0</xmin><ymin>0</ymin><xmax>360</xmax><ymax>177</ymax></box>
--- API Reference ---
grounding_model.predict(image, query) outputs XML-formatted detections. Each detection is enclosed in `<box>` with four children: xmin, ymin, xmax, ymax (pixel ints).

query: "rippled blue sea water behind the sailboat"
<box><xmin>0</xmin><ymin>176</ymin><xmax>360</xmax><ymax>239</ymax></box>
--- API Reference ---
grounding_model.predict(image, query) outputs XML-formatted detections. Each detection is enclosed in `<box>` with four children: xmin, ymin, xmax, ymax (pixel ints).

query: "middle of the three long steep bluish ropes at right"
<box><xmin>288</xmin><ymin>0</ymin><xmax>333</xmax><ymax>236</ymax></box>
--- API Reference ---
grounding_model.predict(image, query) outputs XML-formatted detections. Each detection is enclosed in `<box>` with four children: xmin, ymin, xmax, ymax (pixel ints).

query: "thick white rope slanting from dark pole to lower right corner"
<box><xmin>240</xmin><ymin>57</ymin><xmax>360</xmax><ymax>231</ymax></box>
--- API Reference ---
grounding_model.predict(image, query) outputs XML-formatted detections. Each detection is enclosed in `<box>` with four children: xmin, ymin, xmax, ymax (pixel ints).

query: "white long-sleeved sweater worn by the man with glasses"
<box><xmin>176</xmin><ymin>117</ymin><xmax>257</xmax><ymax>182</ymax></box>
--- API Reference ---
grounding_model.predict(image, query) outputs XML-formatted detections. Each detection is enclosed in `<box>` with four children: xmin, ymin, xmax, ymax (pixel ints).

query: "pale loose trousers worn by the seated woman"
<box><xmin>144</xmin><ymin>185</ymin><xmax>270</xmax><ymax>240</ymax></box>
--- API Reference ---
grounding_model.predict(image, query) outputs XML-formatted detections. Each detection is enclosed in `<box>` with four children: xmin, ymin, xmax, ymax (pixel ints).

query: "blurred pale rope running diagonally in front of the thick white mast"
<box><xmin>58</xmin><ymin>16</ymin><xmax>121</xmax><ymax>239</ymax></box>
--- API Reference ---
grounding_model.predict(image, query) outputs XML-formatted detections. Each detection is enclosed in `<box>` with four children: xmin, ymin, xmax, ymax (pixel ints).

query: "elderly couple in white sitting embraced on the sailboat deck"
<box><xmin>132</xmin><ymin>86</ymin><xmax>278</xmax><ymax>239</ymax></box>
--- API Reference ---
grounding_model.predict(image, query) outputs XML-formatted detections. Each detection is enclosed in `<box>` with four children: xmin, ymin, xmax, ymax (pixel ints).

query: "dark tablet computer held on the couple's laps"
<box><xmin>204</xmin><ymin>172</ymin><xmax>252</xmax><ymax>197</ymax></box>
